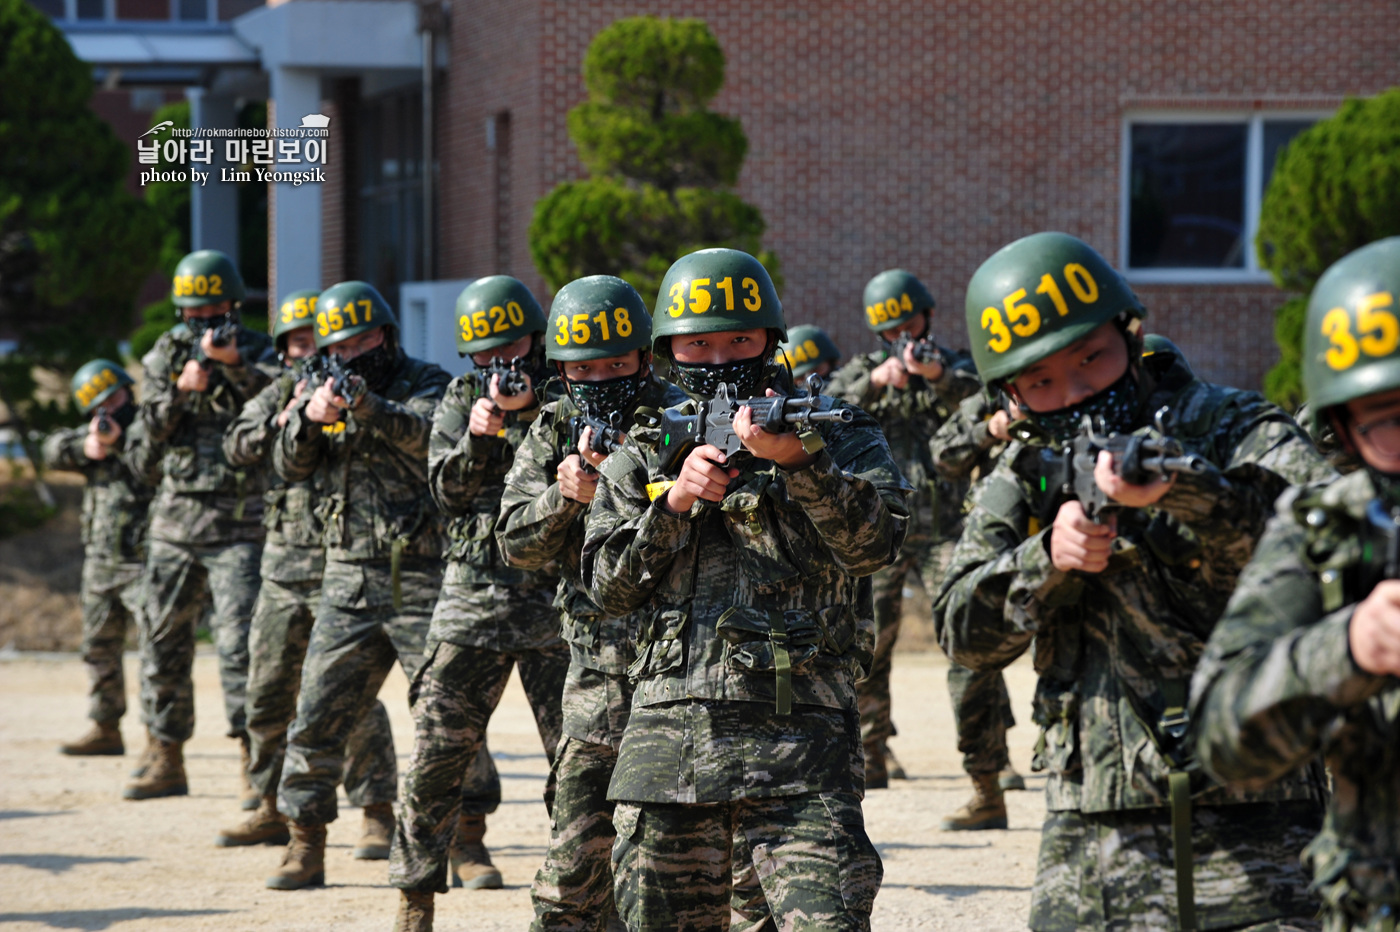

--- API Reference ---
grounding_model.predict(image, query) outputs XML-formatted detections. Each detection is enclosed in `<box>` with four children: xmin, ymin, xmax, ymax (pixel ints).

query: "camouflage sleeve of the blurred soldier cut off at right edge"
<box><xmin>1191</xmin><ymin>491</ymin><xmax>1387</xmax><ymax>785</ymax></box>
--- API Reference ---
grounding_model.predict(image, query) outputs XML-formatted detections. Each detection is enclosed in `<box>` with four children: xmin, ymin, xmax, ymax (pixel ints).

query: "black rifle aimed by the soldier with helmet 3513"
<box><xmin>637</xmin><ymin>372</ymin><xmax>855</xmax><ymax>473</ymax></box>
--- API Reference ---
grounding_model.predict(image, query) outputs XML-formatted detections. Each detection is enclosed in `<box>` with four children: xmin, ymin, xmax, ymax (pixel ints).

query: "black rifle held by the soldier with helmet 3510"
<box><xmin>1043</xmin><ymin>407</ymin><xmax>1210</xmax><ymax>523</ymax></box>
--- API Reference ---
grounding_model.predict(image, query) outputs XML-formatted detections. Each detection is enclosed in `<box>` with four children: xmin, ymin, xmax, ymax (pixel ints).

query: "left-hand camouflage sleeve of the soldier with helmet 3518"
<box><xmin>496</xmin><ymin>411</ymin><xmax>585</xmax><ymax>570</ymax></box>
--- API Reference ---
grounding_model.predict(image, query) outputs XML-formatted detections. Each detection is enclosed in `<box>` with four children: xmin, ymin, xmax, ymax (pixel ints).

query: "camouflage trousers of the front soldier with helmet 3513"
<box><xmin>613</xmin><ymin>793</ymin><xmax>883</xmax><ymax>932</ymax></box>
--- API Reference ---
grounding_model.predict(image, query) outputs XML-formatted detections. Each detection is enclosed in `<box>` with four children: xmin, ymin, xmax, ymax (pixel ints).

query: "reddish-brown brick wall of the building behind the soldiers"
<box><xmin>440</xmin><ymin>0</ymin><xmax>1400</xmax><ymax>388</ymax></box>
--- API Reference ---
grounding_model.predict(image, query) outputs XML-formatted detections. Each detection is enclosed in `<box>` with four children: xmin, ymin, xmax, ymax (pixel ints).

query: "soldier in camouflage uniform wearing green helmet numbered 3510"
<box><xmin>934</xmin><ymin>232</ymin><xmax>1327</xmax><ymax>932</ymax></box>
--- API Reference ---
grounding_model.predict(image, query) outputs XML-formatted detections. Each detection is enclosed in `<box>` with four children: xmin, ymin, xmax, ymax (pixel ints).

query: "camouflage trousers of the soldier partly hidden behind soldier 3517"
<box><xmin>248</xmin><ymin>578</ymin><xmax>399</xmax><ymax>806</ymax></box>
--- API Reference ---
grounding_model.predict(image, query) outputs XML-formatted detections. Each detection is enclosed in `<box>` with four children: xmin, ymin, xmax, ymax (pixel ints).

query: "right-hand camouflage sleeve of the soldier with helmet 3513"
<box><xmin>780</xmin><ymin>424</ymin><xmax>909</xmax><ymax>577</ymax></box>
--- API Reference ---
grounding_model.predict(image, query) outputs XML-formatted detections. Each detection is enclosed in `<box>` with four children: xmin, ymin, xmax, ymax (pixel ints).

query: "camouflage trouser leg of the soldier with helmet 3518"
<box><xmin>529</xmin><ymin>662</ymin><xmax>631</xmax><ymax>932</ymax></box>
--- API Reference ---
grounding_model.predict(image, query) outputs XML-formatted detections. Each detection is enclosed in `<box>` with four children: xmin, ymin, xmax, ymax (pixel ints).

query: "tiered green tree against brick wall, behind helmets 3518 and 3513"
<box><xmin>529</xmin><ymin>17</ymin><xmax>778</xmax><ymax>301</ymax></box>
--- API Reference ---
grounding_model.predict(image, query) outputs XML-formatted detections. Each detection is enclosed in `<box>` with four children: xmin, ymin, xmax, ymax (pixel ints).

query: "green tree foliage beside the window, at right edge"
<box><xmin>1256</xmin><ymin>88</ymin><xmax>1400</xmax><ymax>407</ymax></box>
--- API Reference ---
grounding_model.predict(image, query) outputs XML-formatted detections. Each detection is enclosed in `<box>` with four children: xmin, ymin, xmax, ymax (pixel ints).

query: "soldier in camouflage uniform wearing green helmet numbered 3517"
<box><xmin>267</xmin><ymin>281</ymin><xmax>448</xmax><ymax>890</ymax></box>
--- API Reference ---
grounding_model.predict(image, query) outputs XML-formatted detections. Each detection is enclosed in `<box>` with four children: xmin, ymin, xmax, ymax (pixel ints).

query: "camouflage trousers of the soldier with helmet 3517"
<box><xmin>277</xmin><ymin>587</ymin><xmax>433</xmax><ymax>824</ymax></box>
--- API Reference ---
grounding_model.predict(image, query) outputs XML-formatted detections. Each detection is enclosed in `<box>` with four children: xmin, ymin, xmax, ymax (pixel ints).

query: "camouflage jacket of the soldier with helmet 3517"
<box><xmin>273</xmin><ymin>348</ymin><xmax>449</xmax><ymax>575</ymax></box>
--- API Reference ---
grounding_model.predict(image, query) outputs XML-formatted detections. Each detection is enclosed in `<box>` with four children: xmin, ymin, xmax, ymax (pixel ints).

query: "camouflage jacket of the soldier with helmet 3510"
<box><xmin>934</xmin><ymin>348</ymin><xmax>1330</xmax><ymax>812</ymax></box>
